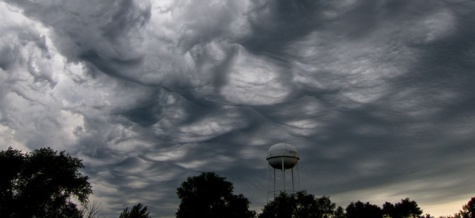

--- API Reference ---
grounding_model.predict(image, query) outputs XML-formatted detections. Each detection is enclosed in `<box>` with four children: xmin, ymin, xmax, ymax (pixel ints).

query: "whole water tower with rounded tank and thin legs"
<box><xmin>266</xmin><ymin>143</ymin><xmax>300</xmax><ymax>201</ymax></box>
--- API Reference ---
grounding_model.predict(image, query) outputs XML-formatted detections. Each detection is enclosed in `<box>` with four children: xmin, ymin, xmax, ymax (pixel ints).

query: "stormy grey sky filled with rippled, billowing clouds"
<box><xmin>0</xmin><ymin>0</ymin><xmax>475</xmax><ymax>217</ymax></box>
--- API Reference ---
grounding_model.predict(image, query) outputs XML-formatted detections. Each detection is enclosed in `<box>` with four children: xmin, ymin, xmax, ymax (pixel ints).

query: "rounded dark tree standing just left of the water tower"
<box><xmin>176</xmin><ymin>172</ymin><xmax>256</xmax><ymax>218</ymax></box>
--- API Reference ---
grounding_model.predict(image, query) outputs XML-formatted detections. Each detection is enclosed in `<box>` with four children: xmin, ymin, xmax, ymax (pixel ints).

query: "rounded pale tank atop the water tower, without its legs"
<box><xmin>266</xmin><ymin>143</ymin><xmax>300</xmax><ymax>170</ymax></box>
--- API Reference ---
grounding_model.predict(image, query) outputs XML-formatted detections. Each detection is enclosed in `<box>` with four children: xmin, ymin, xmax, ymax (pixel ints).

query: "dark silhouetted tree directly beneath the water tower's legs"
<box><xmin>259</xmin><ymin>191</ymin><xmax>342</xmax><ymax>218</ymax></box>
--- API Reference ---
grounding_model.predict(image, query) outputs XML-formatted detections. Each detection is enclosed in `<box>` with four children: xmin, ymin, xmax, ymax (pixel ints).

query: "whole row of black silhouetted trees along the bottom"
<box><xmin>0</xmin><ymin>148</ymin><xmax>475</xmax><ymax>218</ymax></box>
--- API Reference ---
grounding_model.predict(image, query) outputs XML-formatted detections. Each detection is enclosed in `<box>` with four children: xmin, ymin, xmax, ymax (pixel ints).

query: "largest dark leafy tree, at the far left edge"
<box><xmin>0</xmin><ymin>147</ymin><xmax>92</xmax><ymax>218</ymax></box>
